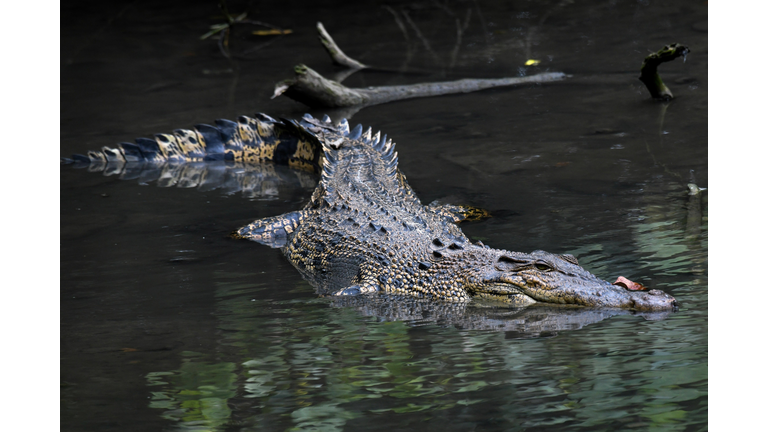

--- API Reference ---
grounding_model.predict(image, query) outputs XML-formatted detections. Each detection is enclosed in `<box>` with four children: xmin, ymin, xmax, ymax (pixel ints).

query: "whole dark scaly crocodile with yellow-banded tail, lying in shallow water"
<box><xmin>66</xmin><ymin>114</ymin><xmax>677</xmax><ymax>311</ymax></box>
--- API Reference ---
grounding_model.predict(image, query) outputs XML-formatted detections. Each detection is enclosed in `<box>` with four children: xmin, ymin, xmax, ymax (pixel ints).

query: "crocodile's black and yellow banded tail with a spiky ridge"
<box><xmin>65</xmin><ymin>114</ymin><xmax>323</xmax><ymax>176</ymax></box>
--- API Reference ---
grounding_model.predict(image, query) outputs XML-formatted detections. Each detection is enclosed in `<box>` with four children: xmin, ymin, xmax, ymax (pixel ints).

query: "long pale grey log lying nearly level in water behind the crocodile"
<box><xmin>272</xmin><ymin>65</ymin><xmax>566</xmax><ymax>108</ymax></box>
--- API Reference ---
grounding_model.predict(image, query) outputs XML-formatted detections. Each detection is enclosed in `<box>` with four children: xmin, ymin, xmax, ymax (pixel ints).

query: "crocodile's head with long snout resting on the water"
<box><xmin>467</xmin><ymin>249</ymin><xmax>677</xmax><ymax>311</ymax></box>
